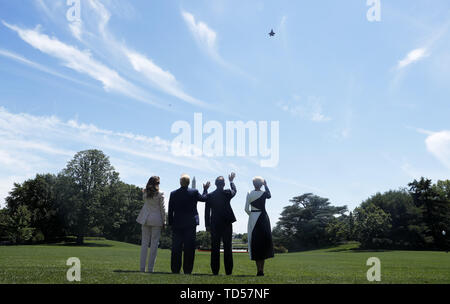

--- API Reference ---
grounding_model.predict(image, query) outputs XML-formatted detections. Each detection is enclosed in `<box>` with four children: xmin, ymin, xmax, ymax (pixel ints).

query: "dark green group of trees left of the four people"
<box><xmin>0</xmin><ymin>150</ymin><xmax>170</xmax><ymax>248</ymax></box>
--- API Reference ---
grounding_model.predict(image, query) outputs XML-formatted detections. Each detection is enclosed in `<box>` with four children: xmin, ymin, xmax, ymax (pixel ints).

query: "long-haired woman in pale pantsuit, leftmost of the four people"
<box><xmin>136</xmin><ymin>176</ymin><xmax>166</xmax><ymax>272</ymax></box>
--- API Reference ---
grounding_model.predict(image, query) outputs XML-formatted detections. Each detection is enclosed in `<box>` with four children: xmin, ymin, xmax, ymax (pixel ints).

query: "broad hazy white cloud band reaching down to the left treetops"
<box><xmin>0</xmin><ymin>107</ymin><xmax>229</xmax><ymax>205</ymax></box>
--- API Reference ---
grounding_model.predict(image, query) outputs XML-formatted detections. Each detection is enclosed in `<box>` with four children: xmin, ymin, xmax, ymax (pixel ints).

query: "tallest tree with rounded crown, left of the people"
<box><xmin>63</xmin><ymin>150</ymin><xmax>119</xmax><ymax>244</ymax></box>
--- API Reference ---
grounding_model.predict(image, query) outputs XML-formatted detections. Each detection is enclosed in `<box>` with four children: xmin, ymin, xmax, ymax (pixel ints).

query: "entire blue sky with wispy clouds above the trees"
<box><xmin>0</xmin><ymin>0</ymin><xmax>450</xmax><ymax>232</ymax></box>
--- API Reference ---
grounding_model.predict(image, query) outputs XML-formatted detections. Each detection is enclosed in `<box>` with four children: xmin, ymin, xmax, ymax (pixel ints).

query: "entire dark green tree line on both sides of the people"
<box><xmin>0</xmin><ymin>150</ymin><xmax>450</xmax><ymax>252</ymax></box>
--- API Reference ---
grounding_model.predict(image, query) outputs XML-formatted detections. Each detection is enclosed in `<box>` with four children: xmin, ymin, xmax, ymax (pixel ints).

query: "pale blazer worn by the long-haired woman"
<box><xmin>136</xmin><ymin>192</ymin><xmax>166</xmax><ymax>227</ymax></box>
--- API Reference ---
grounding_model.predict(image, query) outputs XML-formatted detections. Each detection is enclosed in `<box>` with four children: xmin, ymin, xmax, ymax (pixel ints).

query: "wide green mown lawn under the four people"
<box><xmin>0</xmin><ymin>240</ymin><xmax>450</xmax><ymax>284</ymax></box>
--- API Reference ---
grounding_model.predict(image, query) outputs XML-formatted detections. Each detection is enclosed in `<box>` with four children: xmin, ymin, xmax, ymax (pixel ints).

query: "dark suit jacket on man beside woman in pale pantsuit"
<box><xmin>168</xmin><ymin>187</ymin><xmax>206</xmax><ymax>228</ymax></box>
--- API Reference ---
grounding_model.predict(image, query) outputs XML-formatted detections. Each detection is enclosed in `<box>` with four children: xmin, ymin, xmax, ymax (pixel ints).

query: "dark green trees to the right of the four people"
<box><xmin>273</xmin><ymin>177</ymin><xmax>450</xmax><ymax>251</ymax></box>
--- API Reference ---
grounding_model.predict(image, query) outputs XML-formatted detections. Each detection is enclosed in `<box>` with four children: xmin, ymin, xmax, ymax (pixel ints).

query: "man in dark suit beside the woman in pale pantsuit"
<box><xmin>168</xmin><ymin>174</ymin><xmax>210</xmax><ymax>274</ymax></box>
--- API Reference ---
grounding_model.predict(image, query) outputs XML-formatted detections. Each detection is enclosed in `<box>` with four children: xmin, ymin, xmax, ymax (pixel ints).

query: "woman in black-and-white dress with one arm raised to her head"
<box><xmin>245</xmin><ymin>177</ymin><xmax>274</xmax><ymax>276</ymax></box>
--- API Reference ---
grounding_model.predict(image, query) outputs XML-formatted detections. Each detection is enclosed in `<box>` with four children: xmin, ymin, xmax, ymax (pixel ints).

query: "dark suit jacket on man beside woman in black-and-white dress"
<box><xmin>205</xmin><ymin>183</ymin><xmax>236</xmax><ymax>227</ymax></box>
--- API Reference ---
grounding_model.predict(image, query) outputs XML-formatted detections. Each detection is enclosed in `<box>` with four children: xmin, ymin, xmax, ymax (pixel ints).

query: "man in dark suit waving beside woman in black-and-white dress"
<box><xmin>205</xmin><ymin>173</ymin><xmax>236</xmax><ymax>275</ymax></box>
